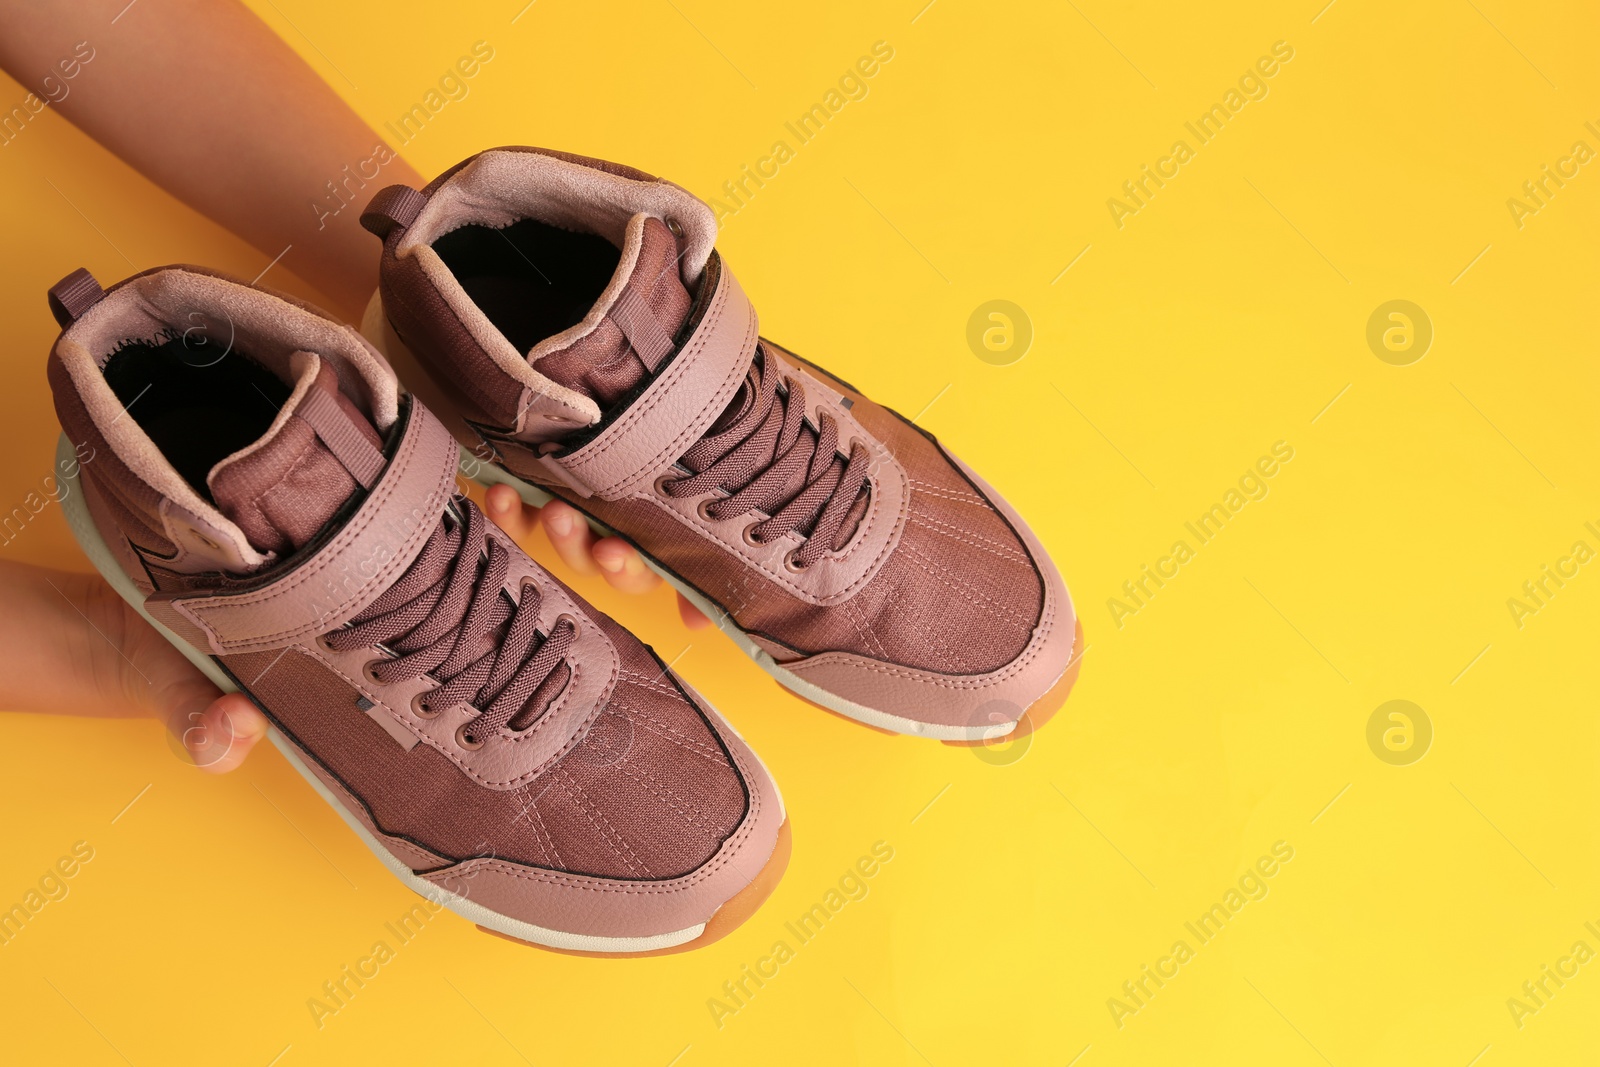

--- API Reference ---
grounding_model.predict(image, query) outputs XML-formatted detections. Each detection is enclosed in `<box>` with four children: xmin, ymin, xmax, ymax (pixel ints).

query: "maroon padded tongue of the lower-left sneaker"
<box><xmin>206</xmin><ymin>352</ymin><xmax>384</xmax><ymax>552</ymax></box>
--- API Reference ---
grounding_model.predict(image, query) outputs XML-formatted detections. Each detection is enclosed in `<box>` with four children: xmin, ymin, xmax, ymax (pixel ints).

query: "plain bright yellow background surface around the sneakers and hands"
<box><xmin>0</xmin><ymin>0</ymin><xmax>1600</xmax><ymax>1067</ymax></box>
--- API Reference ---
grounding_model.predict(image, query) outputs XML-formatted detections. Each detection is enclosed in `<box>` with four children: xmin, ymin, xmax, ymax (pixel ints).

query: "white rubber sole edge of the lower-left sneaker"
<box><xmin>56</xmin><ymin>434</ymin><xmax>707</xmax><ymax>953</ymax></box>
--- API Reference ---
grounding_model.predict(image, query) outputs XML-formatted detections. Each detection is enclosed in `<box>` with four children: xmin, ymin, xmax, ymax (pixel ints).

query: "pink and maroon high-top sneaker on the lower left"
<box><xmin>50</xmin><ymin>267</ymin><xmax>787</xmax><ymax>953</ymax></box>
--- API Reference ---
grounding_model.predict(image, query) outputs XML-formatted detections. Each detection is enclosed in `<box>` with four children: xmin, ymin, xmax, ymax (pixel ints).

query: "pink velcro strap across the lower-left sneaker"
<box><xmin>150</xmin><ymin>400</ymin><xmax>459</xmax><ymax>654</ymax></box>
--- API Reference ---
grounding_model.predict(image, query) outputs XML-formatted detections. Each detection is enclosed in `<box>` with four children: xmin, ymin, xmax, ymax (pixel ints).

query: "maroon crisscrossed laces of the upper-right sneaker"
<box><xmin>661</xmin><ymin>350</ymin><xmax>870</xmax><ymax>571</ymax></box>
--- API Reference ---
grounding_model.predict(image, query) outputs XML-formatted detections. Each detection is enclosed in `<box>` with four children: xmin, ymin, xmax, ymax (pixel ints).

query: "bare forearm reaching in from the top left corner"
<box><xmin>0</xmin><ymin>0</ymin><xmax>421</xmax><ymax>320</ymax></box>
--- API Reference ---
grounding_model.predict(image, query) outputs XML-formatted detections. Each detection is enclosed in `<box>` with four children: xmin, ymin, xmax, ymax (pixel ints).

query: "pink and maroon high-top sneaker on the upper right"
<box><xmin>362</xmin><ymin>147</ymin><xmax>1080</xmax><ymax>742</ymax></box>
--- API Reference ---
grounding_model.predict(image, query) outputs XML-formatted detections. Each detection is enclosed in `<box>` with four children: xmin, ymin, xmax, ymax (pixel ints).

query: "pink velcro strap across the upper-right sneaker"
<box><xmin>544</xmin><ymin>256</ymin><xmax>757</xmax><ymax>501</ymax></box>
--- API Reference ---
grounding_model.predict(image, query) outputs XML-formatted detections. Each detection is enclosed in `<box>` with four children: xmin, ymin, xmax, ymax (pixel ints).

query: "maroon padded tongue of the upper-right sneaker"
<box><xmin>528</xmin><ymin>214</ymin><xmax>694</xmax><ymax>411</ymax></box>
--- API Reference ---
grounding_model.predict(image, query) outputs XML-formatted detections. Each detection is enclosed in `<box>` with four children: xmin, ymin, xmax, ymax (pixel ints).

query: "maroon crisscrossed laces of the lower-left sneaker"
<box><xmin>322</xmin><ymin>496</ymin><xmax>578</xmax><ymax>749</ymax></box>
